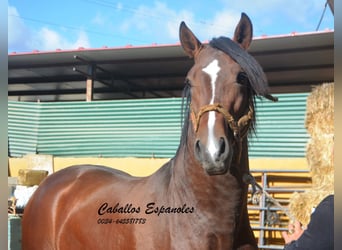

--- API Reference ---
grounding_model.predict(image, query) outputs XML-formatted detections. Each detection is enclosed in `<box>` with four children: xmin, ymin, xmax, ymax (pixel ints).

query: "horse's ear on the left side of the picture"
<box><xmin>179</xmin><ymin>22</ymin><xmax>202</xmax><ymax>58</ymax></box>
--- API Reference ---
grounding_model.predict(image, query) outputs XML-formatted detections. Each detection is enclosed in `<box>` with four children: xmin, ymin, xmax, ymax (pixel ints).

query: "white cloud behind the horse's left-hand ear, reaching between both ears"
<box><xmin>120</xmin><ymin>2</ymin><xmax>240</xmax><ymax>43</ymax></box>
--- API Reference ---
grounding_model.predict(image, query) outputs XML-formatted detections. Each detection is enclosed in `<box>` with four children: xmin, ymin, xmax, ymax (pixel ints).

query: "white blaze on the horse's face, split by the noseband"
<box><xmin>203</xmin><ymin>59</ymin><xmax>221</xmax><ymax>158</ymax></box>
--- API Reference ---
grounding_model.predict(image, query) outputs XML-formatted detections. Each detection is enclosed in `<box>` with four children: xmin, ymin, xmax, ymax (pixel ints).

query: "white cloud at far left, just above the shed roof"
<box><xmin>8</xmin><ymin>6</ymin><xmax>90</xmax><ymax>52</ymax></box>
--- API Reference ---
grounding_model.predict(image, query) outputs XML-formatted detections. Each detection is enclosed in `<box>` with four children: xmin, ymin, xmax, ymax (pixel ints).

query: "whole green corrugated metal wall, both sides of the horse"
<box><xmin>9</xmin><ymin>94</ymin><xmax>307</xmax><ymax>158</ymax></box>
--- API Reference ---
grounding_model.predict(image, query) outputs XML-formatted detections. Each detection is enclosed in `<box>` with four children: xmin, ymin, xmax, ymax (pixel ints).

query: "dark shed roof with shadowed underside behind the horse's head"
<box><xmin>8</xmin><ymin>31</ymin><xmax>334</xmax><ymax>101</ymax></box>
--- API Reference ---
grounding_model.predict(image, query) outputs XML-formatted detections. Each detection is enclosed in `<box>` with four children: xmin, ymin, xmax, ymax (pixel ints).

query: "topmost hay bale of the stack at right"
<box><xmin>305</xmin><ymin>83</ymin><xmax>334</xmax><ymax>136</ymax></box>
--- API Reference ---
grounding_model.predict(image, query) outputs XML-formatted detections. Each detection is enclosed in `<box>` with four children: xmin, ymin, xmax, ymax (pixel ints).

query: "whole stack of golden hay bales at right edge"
<box><xmin>288</xmin><ymin>83</ymin><xmax>334</xmax><ymax>226</ymax></box>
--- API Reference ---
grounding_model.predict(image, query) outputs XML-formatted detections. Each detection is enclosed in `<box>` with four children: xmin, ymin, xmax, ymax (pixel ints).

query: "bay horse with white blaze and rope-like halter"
<box><xmin>22</xmin><ymin>13</ymin><xmax>275</xmax><ymax>250</ymax></box>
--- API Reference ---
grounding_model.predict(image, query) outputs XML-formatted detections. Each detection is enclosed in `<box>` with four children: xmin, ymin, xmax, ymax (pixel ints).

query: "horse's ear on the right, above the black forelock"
<box><xmin>233</xmin><ymin>13</ymin><xmax>253</xmax><ymax>50</ymax></box>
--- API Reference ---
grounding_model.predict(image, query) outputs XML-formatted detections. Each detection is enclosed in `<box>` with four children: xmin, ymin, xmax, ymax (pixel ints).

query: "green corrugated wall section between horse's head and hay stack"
<box><xmin>249</xmin><ymin>93</ymin><xmax>308</xmax><ymax>157</ymax></box>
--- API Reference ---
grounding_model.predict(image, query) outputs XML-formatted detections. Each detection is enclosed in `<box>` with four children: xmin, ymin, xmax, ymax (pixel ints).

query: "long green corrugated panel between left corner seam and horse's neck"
<box><xmin>11</xmin><ymin>98</ymin><xmax>181</xmax><ymax>157</ymax></box>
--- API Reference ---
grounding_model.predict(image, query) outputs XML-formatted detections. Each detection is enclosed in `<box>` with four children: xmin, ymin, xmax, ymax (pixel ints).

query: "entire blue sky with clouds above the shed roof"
<box><xmin>8</xmin><ymin>0</ymin><xmax>334</xmax><ymax>52</ymax></box>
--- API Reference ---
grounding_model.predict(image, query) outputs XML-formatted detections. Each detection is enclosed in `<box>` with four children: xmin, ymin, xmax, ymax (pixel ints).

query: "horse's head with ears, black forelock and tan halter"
<box><xmin>179</xmin><ymin>13</ymin><xmax>274</xmax><ymax>175</ymax></box>
